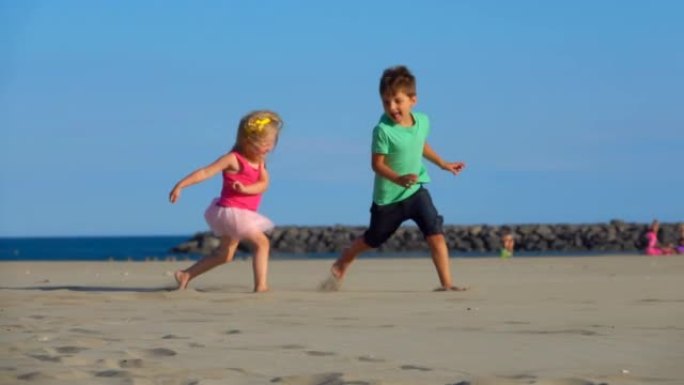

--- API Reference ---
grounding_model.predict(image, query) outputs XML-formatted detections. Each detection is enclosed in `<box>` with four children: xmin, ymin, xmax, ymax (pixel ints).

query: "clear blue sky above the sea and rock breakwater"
<box><xmin>0</xmin><ymin>0</ymin><xmax>684</xmax><ymax>236</ymax></box>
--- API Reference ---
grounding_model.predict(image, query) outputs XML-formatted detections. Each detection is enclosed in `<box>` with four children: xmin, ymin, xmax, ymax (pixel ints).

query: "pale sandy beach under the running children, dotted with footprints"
<box><xmin>0</xmin><ymin>256</ymin><xmax>684</xmax><ymax>385</ymax></box>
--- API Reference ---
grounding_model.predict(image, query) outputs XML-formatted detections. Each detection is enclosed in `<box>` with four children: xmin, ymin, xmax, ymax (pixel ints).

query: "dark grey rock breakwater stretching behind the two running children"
<box><xmin>171</xmin><ymin>220</ymin><xmax>678</xmax><ymax>255</ymax></box>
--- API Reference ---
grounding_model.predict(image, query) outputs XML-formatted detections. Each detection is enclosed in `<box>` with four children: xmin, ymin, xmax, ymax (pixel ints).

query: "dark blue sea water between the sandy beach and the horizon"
<box><xmin>0</xmin><ymin>236</ymin><xmax>624</xmax><ymax>261</ymax></box>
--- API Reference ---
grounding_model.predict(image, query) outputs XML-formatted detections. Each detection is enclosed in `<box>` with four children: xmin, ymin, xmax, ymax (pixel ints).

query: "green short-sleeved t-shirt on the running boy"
<box><xmin>371</xmin><ymin>112</ymin><xmax>430</xmax><ymax>205</ymax></box>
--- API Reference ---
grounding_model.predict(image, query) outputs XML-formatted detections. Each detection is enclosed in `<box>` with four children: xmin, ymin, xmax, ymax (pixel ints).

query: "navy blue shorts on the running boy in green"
<box><xmin>363</xmin><ymin>187</ymin><xmax>444</xmax><ymax>248</ymax></box>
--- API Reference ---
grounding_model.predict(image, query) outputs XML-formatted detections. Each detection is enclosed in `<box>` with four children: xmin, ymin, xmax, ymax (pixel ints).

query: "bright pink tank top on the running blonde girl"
<box><xmin>216</xmin><ymin>151</ymin><xmax>262</xmax><ymax>211</ymax></box>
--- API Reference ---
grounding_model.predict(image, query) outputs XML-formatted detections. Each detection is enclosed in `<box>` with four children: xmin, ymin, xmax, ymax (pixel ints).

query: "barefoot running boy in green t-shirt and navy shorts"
<box><xmin>331</xmin><ymin>66</ymin><xmax>465</xmax><ymax>291</ymax></box>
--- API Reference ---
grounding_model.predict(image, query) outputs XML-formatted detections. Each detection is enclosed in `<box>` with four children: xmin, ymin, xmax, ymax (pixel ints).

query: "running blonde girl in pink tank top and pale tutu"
<box><xmin>169</xmin><ymin>110</ymin><xmax>283</xmax><ymax>292</ymax></box>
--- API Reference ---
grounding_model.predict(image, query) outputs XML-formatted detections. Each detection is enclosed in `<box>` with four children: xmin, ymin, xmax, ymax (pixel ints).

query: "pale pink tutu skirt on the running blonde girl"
<box><xmin>204</xmin><ymin>199</ymin><xmax>273</xmax><ymax>239</ymax></box>
